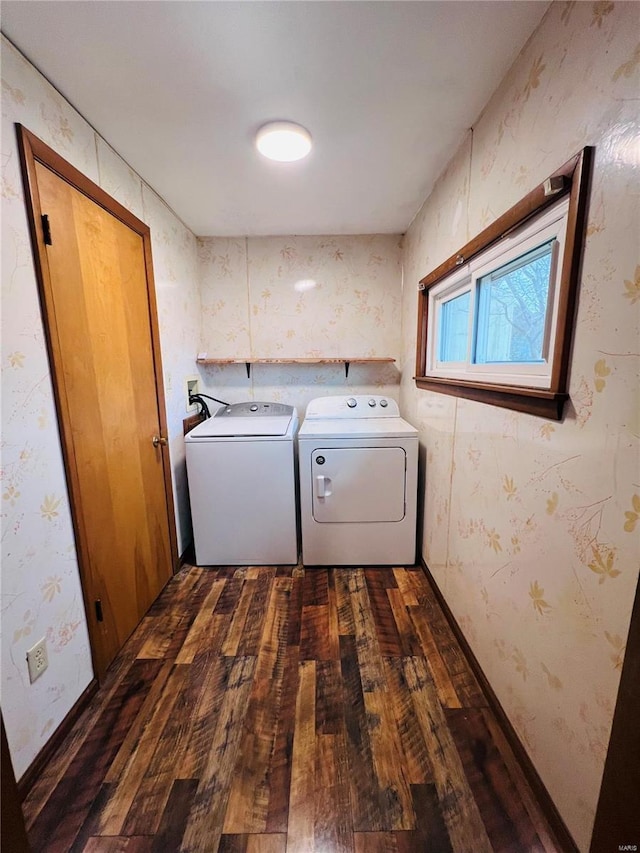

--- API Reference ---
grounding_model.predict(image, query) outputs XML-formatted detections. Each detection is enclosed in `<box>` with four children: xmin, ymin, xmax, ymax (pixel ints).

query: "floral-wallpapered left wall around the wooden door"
<box><xmin>0</xmin><ymin>38</ymin><xmax>200</xmax><ymax>777</ymax></box>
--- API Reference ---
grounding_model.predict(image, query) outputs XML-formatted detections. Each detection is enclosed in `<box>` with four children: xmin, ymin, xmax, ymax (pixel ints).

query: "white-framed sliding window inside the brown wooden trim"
<box><xmin>425</xmin><ymin>199</ymin><xmax>569</xmax><ymax>388</ymax></box>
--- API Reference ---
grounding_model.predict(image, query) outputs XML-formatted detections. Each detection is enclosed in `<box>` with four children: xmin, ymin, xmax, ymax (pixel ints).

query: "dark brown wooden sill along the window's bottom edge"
<box><xmin>414</xmin><ymin>376</ymin><xmax>569</xmax><ymax>421</ymax></box>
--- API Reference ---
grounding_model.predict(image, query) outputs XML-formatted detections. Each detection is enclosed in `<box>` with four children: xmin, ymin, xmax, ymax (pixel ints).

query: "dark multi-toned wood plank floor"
<box><xmin>24</xmin><ymin>566</ymin><xmax>560</xmax><ymax>853</ymax></box>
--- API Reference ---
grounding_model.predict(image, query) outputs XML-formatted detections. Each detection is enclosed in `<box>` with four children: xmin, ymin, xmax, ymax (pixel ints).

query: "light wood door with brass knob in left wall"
<box><xmin>20</xmin><ymin>126</ymin><xmax>173</xmax><ymax>677</ymax></box>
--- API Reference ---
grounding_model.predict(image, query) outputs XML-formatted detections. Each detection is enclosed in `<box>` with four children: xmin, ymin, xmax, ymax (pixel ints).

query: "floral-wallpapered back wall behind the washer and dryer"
<box><xmin>198</xmin><ymin>234</ymin><xmax>402</xmax><ymax>419</ymax></box>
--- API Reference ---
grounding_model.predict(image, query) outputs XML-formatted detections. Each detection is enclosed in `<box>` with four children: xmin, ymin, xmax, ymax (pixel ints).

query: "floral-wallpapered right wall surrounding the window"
<box><xmin>401</xmin><ymin>2</ymin><xmax>640</xmax><ymax>851</ymax></box>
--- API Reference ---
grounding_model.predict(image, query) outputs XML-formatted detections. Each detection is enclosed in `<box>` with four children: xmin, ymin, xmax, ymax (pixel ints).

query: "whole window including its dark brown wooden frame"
<box><xmin>416</xmin><ymin>149</ymin><xmax>593</xmax><ymax>419</ymax></box>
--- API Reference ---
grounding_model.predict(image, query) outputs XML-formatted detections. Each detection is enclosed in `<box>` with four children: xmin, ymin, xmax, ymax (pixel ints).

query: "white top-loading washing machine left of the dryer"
<box><xmin>185</xmin><ymin>402</ymin><xmax>298</xmax><ymax>566</ymax></box>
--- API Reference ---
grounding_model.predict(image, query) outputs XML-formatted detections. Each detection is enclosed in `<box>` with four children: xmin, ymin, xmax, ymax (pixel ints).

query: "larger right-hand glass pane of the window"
<box><xmin>474</xmin><ymin>240</ymin><xmax>556</xmax><ymax>364</ymax></box>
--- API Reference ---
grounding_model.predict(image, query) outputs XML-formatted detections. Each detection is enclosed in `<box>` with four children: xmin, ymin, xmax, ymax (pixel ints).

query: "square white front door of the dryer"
<box><xmin>311</xmin><ymin>447</ymin><xmax>407</xmax><ymax>524</ymax></box>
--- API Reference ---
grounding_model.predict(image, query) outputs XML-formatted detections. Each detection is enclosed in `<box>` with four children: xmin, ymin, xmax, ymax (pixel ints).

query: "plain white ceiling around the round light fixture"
<box><xmin>2</xmin><ymin>0</ymin><xmax>549</xmax><ymax>236</ymax></box>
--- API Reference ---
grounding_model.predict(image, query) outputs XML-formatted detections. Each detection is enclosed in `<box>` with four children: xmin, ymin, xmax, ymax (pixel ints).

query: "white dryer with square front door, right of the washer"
<box><xmin>298</xmin><ymin>396</ymin><xmax>418</xmax><ymax>566</ymax></box>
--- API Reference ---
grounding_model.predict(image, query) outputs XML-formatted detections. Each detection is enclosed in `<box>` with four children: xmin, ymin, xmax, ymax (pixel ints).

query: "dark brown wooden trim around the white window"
<box><xmin>414</xmin><ymin>147</ymin><xmax>595</xmax><ymax>421</ymax></box>
